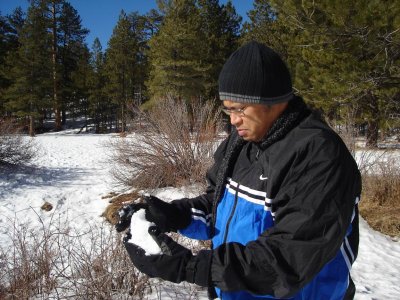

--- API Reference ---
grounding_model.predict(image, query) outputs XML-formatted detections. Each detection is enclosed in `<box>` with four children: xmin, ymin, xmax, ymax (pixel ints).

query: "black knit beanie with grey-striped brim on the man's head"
<box><xmin>218</xmin><ymin>41</ymin><xmax>293</xmax><ymax>105</ymax></box>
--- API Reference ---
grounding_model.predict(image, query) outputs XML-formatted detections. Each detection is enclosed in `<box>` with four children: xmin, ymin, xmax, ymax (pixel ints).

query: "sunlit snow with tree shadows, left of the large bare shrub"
<box><xmin>0</xmin><ymin>134</ymin><xmax>112</xmax><ymax>244</ymax></box>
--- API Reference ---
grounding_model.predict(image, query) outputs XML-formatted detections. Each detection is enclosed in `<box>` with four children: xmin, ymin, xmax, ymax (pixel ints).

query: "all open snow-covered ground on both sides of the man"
<box><xmin>0</xmin><ymin>132</ymin><xmax>400</xmax><ymax>300</ymax></box>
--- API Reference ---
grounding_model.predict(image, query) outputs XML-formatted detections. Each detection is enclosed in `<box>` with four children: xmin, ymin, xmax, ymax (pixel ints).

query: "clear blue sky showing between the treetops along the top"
<box><xmin>0</xmin><ymin>0</ymin><xmax>253</xmax><ymax>49</ymax></box>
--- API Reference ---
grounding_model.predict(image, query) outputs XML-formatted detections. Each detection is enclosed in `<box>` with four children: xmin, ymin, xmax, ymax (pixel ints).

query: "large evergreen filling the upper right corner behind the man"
<box><xmin>245</xmin><ymin>0</ymin><xmax>400</xmax><ymax>146</ymax></box>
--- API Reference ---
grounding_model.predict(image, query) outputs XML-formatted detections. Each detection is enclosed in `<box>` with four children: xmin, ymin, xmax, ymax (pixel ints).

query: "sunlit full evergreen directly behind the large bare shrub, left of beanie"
<box><xmin>147</xmin><ymin>0</ymin><xmax>209</xmax><ymax>106</ymax></box>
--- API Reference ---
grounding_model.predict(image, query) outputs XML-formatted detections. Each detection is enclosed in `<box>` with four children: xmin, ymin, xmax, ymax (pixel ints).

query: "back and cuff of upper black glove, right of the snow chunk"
<box><xmin>144</xmin><ymin>196</ymin><xmax>191</xmax><ymax>232</ymax></box>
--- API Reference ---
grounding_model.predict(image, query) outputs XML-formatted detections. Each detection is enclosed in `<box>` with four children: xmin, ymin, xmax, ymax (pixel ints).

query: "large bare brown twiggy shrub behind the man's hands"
<box><xmin>110</xmin><ymin>97</ymin><xmax>221</xmax><ymax>189</ymax></box>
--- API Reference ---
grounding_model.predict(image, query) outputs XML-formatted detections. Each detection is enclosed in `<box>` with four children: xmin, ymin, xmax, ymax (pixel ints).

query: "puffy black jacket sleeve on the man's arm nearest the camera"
<box><xmin>211</xmin><ymin>135</ymin><xmax>361</xmax><ymax>297</ymax></box>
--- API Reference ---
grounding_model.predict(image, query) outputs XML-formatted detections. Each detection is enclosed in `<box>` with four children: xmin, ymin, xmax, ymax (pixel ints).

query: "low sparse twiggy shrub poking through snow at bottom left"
<box><xmin>0</xmin><ymin>212</ymin><xmax>150</xmax><ymax>299</ymax></box>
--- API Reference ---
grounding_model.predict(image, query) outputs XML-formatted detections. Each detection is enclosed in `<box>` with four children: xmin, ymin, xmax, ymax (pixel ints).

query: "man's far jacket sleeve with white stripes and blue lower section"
<box><xmin>172</xmin><ymin>137</ymin><xmax>229</xmax><ymax>240</ymax></box>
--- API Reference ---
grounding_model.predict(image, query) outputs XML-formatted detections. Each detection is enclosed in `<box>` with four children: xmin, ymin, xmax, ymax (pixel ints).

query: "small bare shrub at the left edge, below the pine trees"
<box><xmin>0</xmin><ymin>120</ymin><xmax>38</xmax><ymax>166</ymax></box>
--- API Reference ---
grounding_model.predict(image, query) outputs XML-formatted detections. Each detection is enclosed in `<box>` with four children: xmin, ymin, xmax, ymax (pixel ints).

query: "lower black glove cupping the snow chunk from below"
<box><xmin>124</xmin><ymin>226</ymin><xmax>212</xmax><ymax>286</ymax></box>
